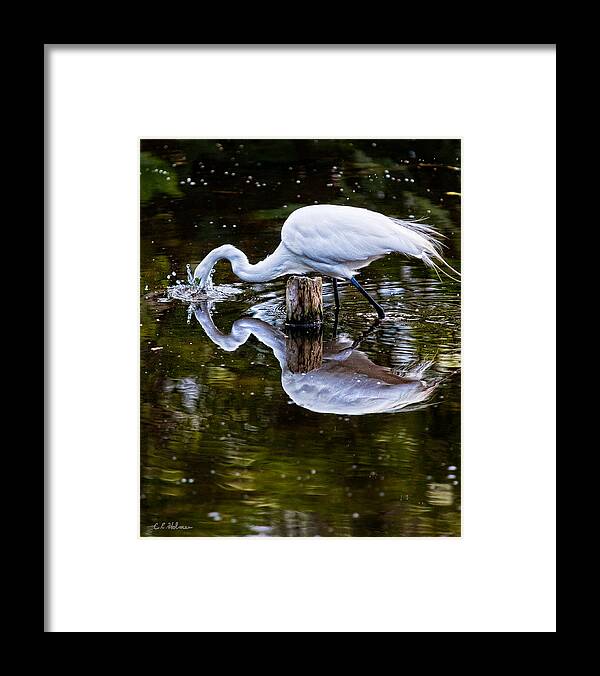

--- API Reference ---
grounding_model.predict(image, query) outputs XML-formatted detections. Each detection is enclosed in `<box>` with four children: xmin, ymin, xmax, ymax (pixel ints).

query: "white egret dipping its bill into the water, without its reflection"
<box><xmin>188</xmin><ymin>204</ymin><xmax>460</xmax><ymax>317</ymax></box>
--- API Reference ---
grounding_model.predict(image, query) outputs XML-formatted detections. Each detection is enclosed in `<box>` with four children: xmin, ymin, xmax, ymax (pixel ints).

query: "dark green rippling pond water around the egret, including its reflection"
<box><xmin>140</xmin><ymin>140</ymin><xmax>461</xmax><ymax>537</ymax></box>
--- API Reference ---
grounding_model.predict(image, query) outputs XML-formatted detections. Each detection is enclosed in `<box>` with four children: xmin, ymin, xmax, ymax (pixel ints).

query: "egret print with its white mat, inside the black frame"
<box><xmin>44</xmin><ymin>44</ymin><xmax>556</xmax><ymax>632</ymax></box>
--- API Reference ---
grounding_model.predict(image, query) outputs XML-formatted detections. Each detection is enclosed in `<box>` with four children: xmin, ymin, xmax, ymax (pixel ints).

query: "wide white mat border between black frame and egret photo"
<box><xmin>46</xmin><ymin>47</ymin><xmax>556</xmax><ymax>631</ymax></box>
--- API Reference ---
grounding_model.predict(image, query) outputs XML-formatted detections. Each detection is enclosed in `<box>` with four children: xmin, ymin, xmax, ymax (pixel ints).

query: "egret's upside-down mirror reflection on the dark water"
<box><xmin>194</xmin><ymin>303</ymin><xmax>441</xmax><ymax>415</ymax></box>
